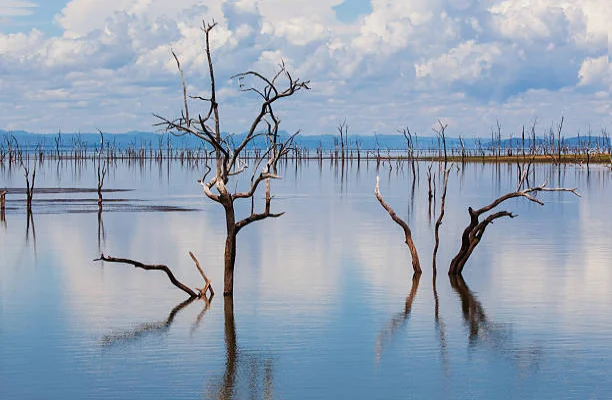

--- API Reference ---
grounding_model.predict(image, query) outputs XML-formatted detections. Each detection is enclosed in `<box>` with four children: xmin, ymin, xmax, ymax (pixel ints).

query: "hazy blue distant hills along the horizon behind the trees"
<box><xmin>0</xmin><ymin>130</ymin><xmax>609</xmax><ymax>150</ymax></box>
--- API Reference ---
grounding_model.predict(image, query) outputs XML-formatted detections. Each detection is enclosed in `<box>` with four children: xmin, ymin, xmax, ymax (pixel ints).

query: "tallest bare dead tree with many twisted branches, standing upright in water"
<box><xmin>155</xmin><ymin>22</ymin><xmax>309</xmax><ymax>295</ymax></box>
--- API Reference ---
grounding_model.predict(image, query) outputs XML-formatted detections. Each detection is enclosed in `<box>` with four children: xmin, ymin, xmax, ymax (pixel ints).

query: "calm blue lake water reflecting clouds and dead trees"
<box><xmin>0</xmin><ymin>162</ymin><xmax>612</xmax><ymax>399</ymax></box>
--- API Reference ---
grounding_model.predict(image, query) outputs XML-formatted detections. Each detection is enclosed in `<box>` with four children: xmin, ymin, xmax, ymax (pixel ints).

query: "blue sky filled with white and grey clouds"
<box><xmin>0</xmin><ymin>0</ymin><xmax>612</xmax><ymax>137</ymax></box>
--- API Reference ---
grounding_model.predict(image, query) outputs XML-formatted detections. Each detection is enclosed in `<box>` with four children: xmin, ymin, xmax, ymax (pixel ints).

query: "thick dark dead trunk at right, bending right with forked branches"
<box><xmin>448</xmin><ymin>168</ymin><xmax>580</xmax><ymax>275</ymax></box>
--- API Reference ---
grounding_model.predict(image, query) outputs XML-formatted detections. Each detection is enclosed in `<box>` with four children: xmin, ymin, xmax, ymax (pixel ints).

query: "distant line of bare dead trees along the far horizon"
<box><xmin>0</xmin><ymin>117</ymin><xmax>612</xmax><ymax>167</ymax></box>
